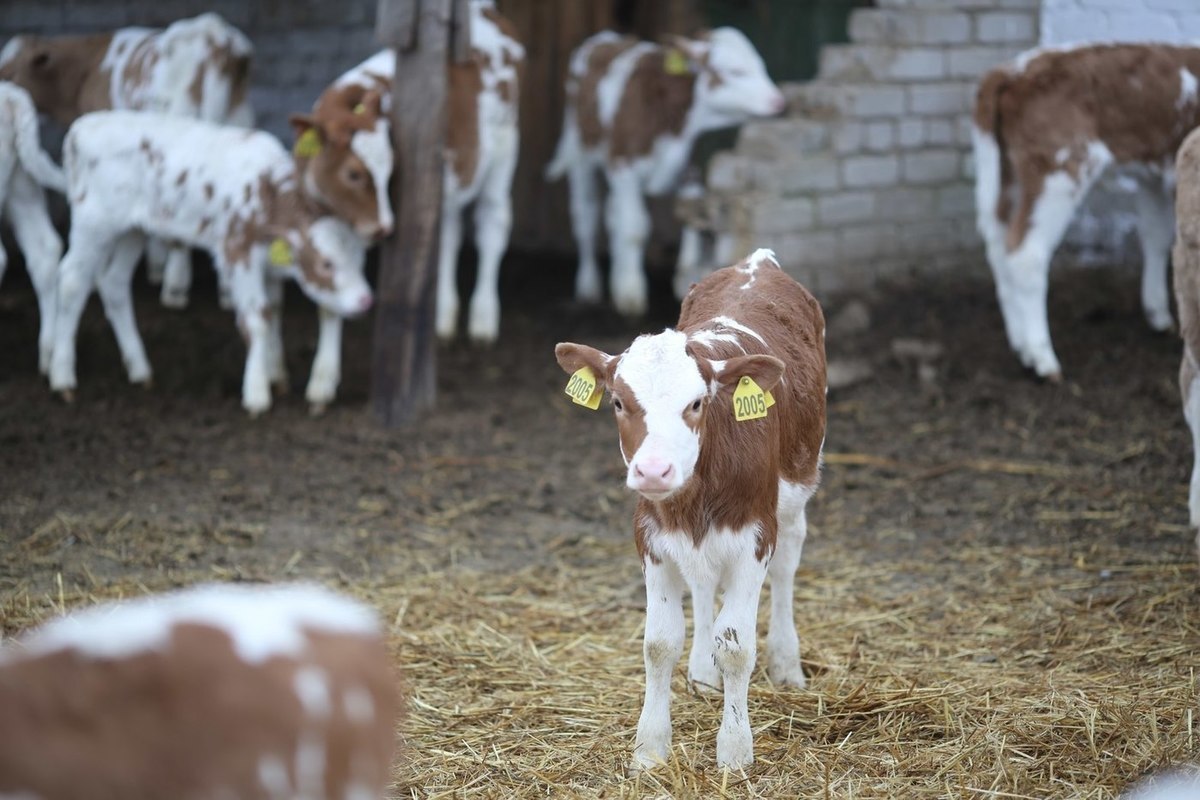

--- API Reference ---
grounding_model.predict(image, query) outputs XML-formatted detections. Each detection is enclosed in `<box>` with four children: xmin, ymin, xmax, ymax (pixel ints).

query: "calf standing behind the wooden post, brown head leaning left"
<box><xmin>293</xmin><ymin>0</ymin><xmax>524</xmax><ymax>342</ymax></box>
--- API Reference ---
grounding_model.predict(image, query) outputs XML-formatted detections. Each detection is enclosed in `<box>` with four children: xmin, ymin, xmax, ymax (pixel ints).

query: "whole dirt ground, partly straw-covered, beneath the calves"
<box><xmin>0</xmin><ymin>251</ymin><xmax>1200</xmax><ymax>798</ymax></box>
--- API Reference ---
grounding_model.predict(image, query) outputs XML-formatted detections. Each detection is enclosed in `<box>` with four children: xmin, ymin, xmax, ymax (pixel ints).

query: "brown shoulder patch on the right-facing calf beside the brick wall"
<box><xmin>608</xmin><ymin>49</ymin><xmax>696</xmax><ymax>160</ymax></box>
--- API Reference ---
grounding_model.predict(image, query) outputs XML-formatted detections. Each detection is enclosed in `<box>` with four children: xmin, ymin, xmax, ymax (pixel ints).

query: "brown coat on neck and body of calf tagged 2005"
<box><xmin>630</xmin><ymin>263</ymin><xmax>826</xmax><ymax>558</ymax></box>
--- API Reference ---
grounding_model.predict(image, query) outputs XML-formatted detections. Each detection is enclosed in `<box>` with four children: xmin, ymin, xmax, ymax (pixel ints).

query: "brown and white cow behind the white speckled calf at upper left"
<box><xmin>0</xmin><ymin>13</ymin><xmax>254</xmax><ymax>308</ymax></box>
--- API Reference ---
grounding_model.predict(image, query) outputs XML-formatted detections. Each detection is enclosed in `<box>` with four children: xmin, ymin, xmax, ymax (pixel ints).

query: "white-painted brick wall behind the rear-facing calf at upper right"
<box><xmin>1040</xmin><ymin>0</ymin><xmax>1200</xmax><ymax>264</ymax></box>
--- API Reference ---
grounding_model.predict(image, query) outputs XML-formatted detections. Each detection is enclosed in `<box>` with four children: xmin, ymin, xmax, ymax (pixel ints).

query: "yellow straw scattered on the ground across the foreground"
<box><xmin>0</xmin><ymin>519</ymin><xmax>1200</xmax><ymax>799</ymax></box>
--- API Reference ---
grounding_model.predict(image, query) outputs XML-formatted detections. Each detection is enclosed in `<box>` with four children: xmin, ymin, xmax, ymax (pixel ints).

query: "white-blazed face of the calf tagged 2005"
<box><xmin>613</xmin><ymin>330</ymin><xmax>709</xmax><ymax>500</ymax></box>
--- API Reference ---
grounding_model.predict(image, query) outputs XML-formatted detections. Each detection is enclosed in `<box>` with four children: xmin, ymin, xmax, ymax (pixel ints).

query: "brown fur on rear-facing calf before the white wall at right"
<box><xmin>974</xmin><ymin>44</ymin><xmax>1200</xmax><ymax>251</ymax></box>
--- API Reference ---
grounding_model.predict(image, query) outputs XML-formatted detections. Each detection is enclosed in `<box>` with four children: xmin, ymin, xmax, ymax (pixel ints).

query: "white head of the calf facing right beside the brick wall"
<box><xmin>696</xmin><ymin>28</ymin><xmax>786</xmax><ymax>124</ymax></box>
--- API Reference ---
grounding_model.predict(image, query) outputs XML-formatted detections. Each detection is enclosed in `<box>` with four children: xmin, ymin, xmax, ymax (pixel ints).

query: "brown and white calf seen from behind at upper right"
<box><xmin>972</xmin><ymin>44</ymin><xmax>1200</xmax><ymax>380</ymax></box>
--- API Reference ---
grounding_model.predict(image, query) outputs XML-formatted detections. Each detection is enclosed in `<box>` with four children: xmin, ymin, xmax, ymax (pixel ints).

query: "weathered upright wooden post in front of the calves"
<box><xmin>371</xmin><ymin>0</ymin><xmax>456</xmax><ymax>427</ymax></box>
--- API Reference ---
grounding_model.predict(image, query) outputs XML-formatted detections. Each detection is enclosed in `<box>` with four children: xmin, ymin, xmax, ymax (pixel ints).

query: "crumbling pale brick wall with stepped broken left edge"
<box><xmin>700</xmin><ymin>0</ymin><xmax>1040</xmax><ymax>293</ymax></box>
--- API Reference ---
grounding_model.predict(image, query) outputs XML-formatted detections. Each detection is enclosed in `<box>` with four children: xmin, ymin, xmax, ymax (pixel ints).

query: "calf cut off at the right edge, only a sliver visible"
<box><xmin>1174</xmin><ymin>130</ymin><xmax>1200</xmax><ymax>557</ymax></box>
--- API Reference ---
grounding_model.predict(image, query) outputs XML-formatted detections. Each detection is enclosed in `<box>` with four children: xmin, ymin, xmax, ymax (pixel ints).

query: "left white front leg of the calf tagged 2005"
<box><xmin>631</xmin><ymin>557</ymin><xmax>685</xmax><ymax>771</ymax></box>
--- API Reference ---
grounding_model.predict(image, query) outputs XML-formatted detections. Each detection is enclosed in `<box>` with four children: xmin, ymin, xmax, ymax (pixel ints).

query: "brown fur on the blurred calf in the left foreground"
<box><xmin>0</xmin><ymin>624</ymin><xmax>400</xmax><ymax>800</ymax></box>
